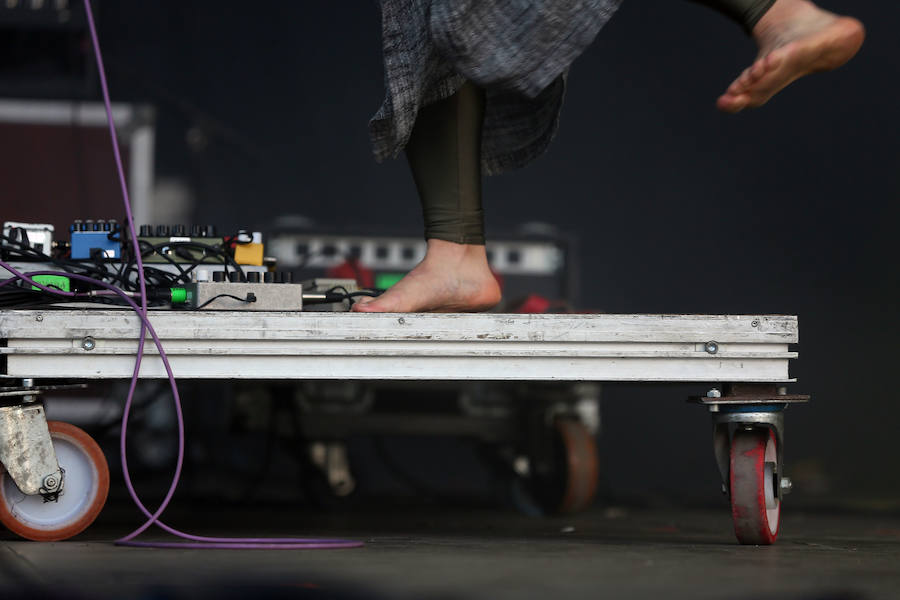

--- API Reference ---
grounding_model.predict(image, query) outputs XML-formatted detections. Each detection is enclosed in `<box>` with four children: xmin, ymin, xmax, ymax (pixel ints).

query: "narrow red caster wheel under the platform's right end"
<box><xmin>729</xmin><ymin>428</ymin><xmax>781</xmax><ymax>545</ymax></box>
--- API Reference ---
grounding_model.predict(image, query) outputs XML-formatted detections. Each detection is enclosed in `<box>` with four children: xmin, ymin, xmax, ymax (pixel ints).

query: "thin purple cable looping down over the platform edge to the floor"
<box><xmin>52</xmin><ymin>0</ymin><xmax>363</xmax><ymax>550</ymax></box>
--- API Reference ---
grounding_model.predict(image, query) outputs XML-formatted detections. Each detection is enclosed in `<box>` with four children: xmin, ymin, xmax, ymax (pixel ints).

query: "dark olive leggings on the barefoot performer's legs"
<box><xmin>406</xmin><ymin>0</ymin><xmax>775</xmax><ymax>245</ymax></box>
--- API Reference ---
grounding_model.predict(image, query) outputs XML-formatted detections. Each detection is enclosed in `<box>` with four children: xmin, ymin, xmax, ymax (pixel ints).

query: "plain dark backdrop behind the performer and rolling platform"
<box><xmin>4</xmin><ymin>0</ymin><xmax>900</xmax><ymax>508</ymax></box>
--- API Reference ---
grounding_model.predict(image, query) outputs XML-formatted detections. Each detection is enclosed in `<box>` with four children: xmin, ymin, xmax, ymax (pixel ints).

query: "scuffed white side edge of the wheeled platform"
<box><xmin>0</xmin><ymin>309</ymin><xmax>799</xmax><ymax>383</ymax></box>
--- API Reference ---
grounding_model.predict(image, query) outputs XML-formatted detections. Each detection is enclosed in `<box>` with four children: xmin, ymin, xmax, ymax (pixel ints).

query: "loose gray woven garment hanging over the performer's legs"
<box><xmin>369</xmin><ymin>0</ymin><xmax>621</xmax><ymax>175</ymax></box>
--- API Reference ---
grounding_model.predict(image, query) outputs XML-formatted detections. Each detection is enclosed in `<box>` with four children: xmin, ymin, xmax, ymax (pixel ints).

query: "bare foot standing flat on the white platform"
<box><xmin>353</xmin><ymin>240</ymin><xmax>500</xmax><ymax>312</ymax></box>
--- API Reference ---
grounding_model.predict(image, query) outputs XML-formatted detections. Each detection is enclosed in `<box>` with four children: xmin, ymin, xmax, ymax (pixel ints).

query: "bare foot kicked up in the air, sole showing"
<box><xmin>716</xmin><ymin>0</ymin><xmax>866</xmax><ymax>113</ymax></box>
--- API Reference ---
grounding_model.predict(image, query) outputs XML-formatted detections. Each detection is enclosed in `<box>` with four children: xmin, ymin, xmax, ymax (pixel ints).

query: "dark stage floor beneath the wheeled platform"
<box><xmin>0</xmin><ymin>506</ymin><xmax>900</xmax><ymax>600</ymax></box>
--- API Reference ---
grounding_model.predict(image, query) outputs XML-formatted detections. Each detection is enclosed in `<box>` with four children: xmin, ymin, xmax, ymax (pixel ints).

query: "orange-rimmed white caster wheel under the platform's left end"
<box><xmin>0</xmin><ymin>421</ymin><xmax>109</xmax><ymax>542</ymax></box>
